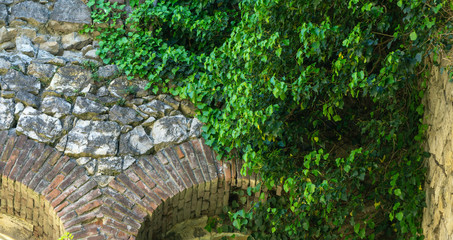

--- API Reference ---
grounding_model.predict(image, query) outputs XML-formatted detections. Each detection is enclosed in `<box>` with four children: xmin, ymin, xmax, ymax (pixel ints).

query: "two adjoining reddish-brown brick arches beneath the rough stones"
<box><xmin>0</xmin><ymin>131</ymin><xmax>256</xmax><ymax>240</ymax></box>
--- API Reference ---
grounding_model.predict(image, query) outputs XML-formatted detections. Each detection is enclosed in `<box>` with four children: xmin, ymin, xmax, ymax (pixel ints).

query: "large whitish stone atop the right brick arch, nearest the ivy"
<box><xmin>151</xmin><ymin>115</ymin><xmax>189</xmax><ymax>150</ymax></box>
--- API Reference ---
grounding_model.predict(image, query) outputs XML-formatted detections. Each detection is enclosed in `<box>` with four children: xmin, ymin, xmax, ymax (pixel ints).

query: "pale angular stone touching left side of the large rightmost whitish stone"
<box><xmin>120</xmin><ymin>126</ymin><xmax>154</xmax><ymax>155</ymax></box>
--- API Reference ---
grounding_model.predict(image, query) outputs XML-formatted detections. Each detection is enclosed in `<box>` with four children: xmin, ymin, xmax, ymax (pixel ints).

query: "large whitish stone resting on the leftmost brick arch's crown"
<box><xmin>16</xmin><ymin>107</ymin><xmax>63</xmax><ymax>143</ymax></box>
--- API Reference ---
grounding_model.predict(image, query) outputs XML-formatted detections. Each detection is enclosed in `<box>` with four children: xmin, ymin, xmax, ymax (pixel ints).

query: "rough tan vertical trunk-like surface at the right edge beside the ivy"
<box><xmin>423</xmin><ymin>52</ymin><xmax>453</xmax><ymax>240</ymax></box>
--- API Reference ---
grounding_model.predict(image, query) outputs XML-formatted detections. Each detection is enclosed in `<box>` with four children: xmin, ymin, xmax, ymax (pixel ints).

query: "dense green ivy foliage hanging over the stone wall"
<box><xmin>87</xmin><ymin>0</ymin><xmax>453</xmax><ymax>239</ymax></box>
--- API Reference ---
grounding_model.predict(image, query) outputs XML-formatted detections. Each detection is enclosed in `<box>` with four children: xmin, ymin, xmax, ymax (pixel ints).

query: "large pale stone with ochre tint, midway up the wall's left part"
<box><xmin>47</xmin><ymin>65</ymin><xmax>91</xmax><ymax>96</ymax></box>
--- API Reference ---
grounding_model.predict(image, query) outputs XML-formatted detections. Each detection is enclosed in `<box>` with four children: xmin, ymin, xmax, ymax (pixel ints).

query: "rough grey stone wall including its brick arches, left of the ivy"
<box><xmin>0</xmin><ymin>0</ymin><xmax>259</xmax><ymax>240</ymax></box>
